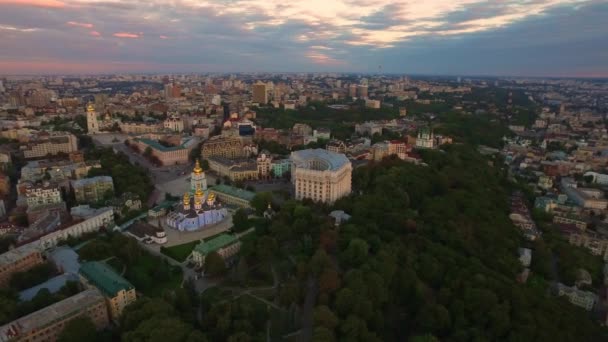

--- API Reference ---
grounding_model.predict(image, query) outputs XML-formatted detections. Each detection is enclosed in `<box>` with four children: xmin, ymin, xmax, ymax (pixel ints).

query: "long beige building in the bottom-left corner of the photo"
<box><xmin>0</xmin><ymin>289</ymin><xmax>109</xmax><ymax>342</ymax></box>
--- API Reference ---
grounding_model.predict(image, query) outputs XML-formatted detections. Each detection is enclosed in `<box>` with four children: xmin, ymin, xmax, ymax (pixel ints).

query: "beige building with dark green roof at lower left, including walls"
<box><xmin>79</xmin><ymin>261</ymin><xmax>137</xmax><ymax>321</ymax></box>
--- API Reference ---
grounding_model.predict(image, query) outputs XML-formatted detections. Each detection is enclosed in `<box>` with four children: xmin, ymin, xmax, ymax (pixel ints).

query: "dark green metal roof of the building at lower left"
<box><xmin>80</xmin><ymin>261</ymin><xmax>135</xmax><ymax>297</ymax></box>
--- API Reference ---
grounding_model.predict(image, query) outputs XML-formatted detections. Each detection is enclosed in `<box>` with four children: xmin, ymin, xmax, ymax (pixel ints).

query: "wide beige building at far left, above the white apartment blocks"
<box><xmin>21</xmin><ymin>132</ymin><xmax>78</xmax><ymax>158</ymax></box>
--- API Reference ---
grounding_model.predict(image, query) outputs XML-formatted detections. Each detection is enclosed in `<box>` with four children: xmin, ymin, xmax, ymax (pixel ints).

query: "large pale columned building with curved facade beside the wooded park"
<box><xmin>291</xmin><ymin>149</ymin><xmax>352</xmax><ymax>203</ymax></box>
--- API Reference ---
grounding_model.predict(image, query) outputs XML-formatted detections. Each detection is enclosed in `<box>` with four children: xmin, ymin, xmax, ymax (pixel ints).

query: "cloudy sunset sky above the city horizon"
<box><xmin>0</xmin><ymin>0</ymin><xmax>608</xmax><ymax>77</ymax></box>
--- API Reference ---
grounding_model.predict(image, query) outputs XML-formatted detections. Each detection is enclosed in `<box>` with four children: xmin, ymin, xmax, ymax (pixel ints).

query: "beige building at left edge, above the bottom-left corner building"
<box><xmin>0</xmin><ymin>241</ymin><xmax>44</xmax><ymax>288</ymax></box>
